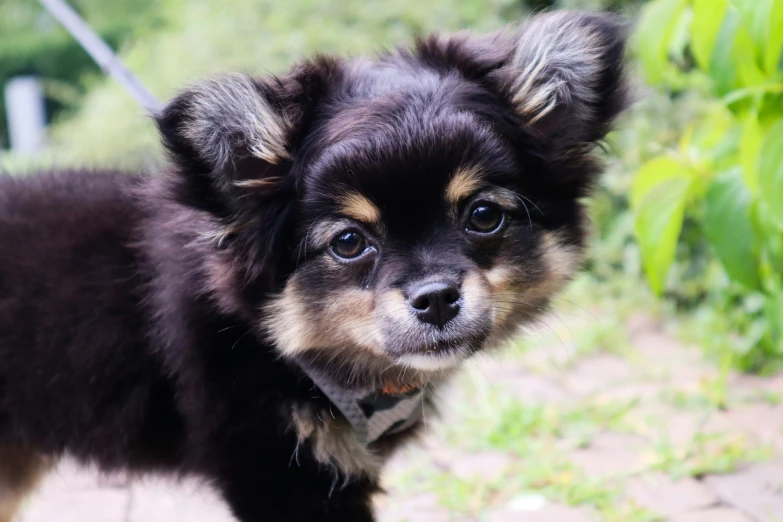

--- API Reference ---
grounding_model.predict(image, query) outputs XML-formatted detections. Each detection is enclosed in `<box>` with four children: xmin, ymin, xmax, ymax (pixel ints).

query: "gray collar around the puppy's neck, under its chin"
<box><xmin>303</xmin><ymin>368</ymin><xmax>425</xmax><ymax>446</ymax></box>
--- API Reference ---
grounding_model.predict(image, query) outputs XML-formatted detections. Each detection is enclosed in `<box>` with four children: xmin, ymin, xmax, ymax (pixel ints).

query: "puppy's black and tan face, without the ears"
<box><xmin>266</xmin><ymin>96</ymin><xmax>579</xmax><ymax>370</ymax></box>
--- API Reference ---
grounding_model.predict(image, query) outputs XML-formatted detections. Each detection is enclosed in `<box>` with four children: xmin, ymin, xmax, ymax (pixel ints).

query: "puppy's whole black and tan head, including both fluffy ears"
<box><xmin>158</xmin><ymin>12</ymin><xmax>626</xmax><ymax>384</ymax></box>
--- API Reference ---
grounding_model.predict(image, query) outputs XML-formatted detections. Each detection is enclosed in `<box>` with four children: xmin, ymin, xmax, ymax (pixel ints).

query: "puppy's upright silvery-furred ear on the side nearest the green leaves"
<box><xmin>502</xmin><ymin>11</ymin><xmax>628</xmax><ymax>149</ymax></box>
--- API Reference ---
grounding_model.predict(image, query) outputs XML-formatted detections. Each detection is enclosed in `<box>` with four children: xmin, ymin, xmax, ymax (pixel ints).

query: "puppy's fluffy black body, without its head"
<box><xmin>0</xmin><ymin>172</ymin><xmax>384</xmax><ymax>522</ymax></box>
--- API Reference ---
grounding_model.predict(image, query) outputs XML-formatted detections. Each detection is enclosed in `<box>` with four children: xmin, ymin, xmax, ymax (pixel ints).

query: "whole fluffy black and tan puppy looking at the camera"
<box><xmin>0</xmin><ymin>12</ymin><xmax>628</xmax><ymax>522</ymax></box>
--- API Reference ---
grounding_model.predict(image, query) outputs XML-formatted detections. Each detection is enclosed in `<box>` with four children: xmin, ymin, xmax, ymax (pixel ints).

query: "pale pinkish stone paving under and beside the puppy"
<box><xmin>16</xmin><ymin>310</ymin><xmax>783</xmax><ymax>522</ymax></box>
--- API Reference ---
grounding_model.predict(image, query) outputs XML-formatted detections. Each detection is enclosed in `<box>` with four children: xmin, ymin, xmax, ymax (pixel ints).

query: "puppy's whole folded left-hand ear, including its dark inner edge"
<box><xmin>155</xmin><ymin>59</ymin><xmax>336</xmax><ymax>214</ymax></box>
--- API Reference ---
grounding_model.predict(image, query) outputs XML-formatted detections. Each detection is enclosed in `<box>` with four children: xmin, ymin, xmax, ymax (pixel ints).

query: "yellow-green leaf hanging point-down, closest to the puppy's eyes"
<box><xmin>634</xmin><ymin>176</ymin><xmax>692</xmax><ymax>294</ymax></box>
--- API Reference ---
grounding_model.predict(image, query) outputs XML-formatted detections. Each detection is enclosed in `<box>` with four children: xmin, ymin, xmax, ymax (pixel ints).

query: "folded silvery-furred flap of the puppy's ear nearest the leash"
<box><xmin>155</xmin><ymin>74</ymin><xmax>291</xmax><ymax>218</ymax></box>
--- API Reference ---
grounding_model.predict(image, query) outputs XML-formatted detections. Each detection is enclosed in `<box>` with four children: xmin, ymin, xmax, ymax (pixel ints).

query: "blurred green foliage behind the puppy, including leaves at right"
<box><xmin>0</xmin><ymin>0</ymin><xmax>783</xmax><ymax>372</ymax></box>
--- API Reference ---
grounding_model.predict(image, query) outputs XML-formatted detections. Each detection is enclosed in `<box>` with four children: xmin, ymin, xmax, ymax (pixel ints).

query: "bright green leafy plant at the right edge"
<box><xmin>631</xmin><ymin>0</ymin><xmax>783</xmax><ymax>369</ymax></box>
